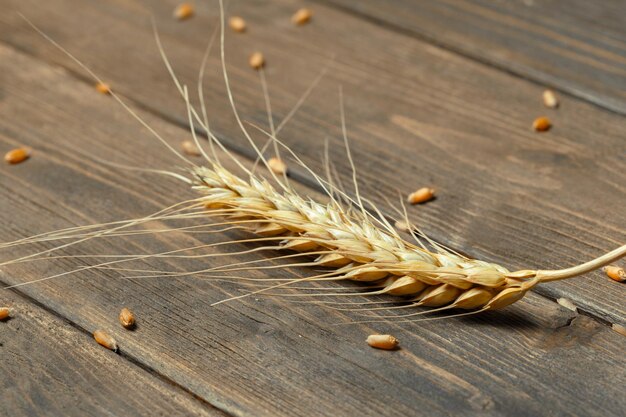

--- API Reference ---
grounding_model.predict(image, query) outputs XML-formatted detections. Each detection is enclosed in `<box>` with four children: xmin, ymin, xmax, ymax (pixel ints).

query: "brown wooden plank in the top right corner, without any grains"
<box><xmin>321</xmin><ymin>0</ymin><xmax>626</xmax><ymax>114</ymax></box>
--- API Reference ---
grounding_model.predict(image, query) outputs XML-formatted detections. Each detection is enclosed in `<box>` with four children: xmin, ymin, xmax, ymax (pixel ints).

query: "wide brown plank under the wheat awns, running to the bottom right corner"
<box><xmin>0</xmin><ymin>35</ymin><xmax>626</xmax><ymax>416</ymax></box>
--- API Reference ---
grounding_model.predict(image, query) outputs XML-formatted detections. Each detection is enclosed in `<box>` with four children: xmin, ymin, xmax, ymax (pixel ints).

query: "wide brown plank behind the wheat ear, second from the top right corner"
<box><xmin>0</xmin><ymin>0</ymin><xmax>626</xmax><ymax>322</ymax></box>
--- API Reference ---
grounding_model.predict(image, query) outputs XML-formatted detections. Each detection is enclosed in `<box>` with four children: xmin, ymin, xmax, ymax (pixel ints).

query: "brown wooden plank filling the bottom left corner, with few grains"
<box><xmin>0</xmin><ymin>291</ymin><xmax>226</xmax><ymax>416</ymax></box>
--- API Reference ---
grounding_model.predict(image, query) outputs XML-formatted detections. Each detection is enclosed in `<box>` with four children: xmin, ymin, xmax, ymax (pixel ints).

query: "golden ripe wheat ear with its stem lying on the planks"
<box><xmin>192</xmin><ymin>159</ymin><xmax>626</xmax><ymax>310</ymax></box>
